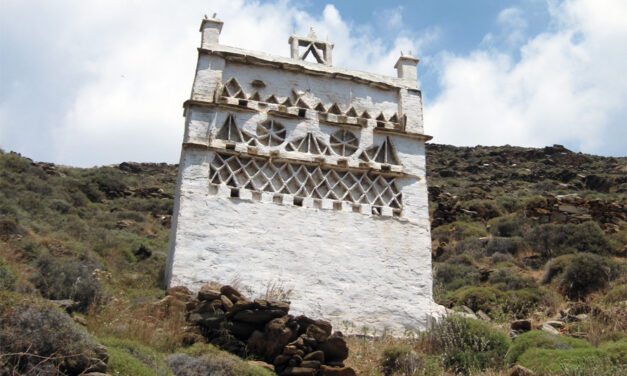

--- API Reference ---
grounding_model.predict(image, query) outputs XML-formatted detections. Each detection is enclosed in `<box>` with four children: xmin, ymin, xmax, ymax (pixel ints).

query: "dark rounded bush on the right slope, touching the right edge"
<box><xmin>560</xmin><ymin>253</ymin><xmax>625</xmax><ymax>299</ymax></box>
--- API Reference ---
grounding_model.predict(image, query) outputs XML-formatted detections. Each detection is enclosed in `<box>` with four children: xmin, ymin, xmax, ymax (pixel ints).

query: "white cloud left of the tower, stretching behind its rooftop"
<box><xmin>0</xmin><ymin>0</ymin><xmax>430</xmax><ymax>166</ymax></box>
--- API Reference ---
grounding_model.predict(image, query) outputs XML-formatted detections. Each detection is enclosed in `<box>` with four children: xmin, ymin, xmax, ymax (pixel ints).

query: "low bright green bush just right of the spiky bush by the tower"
<box><xmin>505</xmin><ymin>330</ymin><xmax>592</xmax><ymax>366</ymax></box>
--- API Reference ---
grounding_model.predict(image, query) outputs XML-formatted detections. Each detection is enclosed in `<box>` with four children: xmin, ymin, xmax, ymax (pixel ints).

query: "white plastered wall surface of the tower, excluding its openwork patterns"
<box><xmin>166</xmin><ymin>49</ymin><xmax>440</xmax><ymax>334</ymax></box>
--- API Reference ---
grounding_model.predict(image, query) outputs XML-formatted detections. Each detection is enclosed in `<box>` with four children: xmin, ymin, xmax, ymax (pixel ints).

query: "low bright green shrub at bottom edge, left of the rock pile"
<box><xmin>100</xmin><ymin>337</ymin><xmax>172</xmax><ymax>376</ymax></box>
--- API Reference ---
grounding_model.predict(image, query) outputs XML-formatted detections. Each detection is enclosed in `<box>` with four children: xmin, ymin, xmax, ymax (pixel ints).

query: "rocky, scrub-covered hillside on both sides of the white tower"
<box><xmin>0</xmin><ymin>144</ymin><xmax>627</xmax><ymax>375</ymax></box>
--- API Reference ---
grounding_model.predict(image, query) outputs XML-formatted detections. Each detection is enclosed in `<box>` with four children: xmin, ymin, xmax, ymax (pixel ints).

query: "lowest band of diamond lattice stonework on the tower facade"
<box><xmin>209</xmin><ymin>153</ymin><xmax>402</xmax><ymax>210</ymax></box>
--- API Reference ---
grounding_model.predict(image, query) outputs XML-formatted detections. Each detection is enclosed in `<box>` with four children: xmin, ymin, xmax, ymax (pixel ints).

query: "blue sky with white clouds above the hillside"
<box><xmin>0</xmin><ymin>0</ymin><xmax>627</xmax><ymax>167</ymax></box>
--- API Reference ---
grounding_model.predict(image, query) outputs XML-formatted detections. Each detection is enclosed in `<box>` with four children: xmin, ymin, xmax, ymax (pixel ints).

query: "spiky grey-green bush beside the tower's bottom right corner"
<box><xmin>425</xmin><ymin>316</ymin><xmax>510</xmax><ymax>375</ymax></box>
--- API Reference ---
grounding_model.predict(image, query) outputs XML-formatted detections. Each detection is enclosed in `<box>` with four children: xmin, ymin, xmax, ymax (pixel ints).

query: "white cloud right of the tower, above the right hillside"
<box><xmin>425</xmin><ymin>0</ymin><xmax>627</xmax><ymax>155</ymax></box>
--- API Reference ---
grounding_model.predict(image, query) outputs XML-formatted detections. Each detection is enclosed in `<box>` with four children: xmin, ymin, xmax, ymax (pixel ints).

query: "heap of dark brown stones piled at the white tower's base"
<box><xmin>167</xmin><ymin>282</ymin><xmax>355</xmax><ymax>376</ymax></box>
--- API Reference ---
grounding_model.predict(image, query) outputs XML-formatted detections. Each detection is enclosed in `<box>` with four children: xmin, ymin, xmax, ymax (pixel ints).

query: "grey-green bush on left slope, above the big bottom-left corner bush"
<box><xmin>32</xmin><ymin>253</ymin><xmax>103</xmax><ymax>312</ymax></box>
